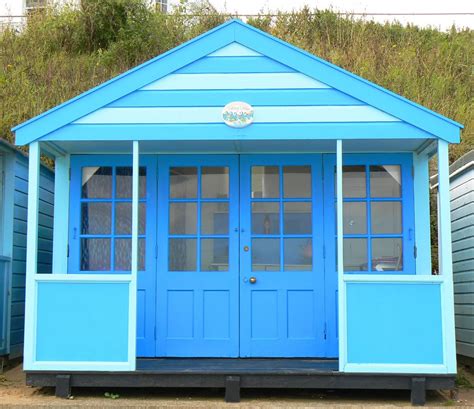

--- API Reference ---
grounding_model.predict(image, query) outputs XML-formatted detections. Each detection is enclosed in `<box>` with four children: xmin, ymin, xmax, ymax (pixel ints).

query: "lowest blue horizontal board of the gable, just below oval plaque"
<box><xmin>44</xmin><ymin>122</ymin><xmax>433</xmax><ymax>141</ymax></box>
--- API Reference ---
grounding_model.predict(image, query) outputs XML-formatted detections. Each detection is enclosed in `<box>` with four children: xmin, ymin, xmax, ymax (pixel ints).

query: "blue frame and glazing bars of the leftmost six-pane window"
<box><xmin>68</xmin><ymin>155</ymin><xmax>157</xmax><ymax>275</ymax></box>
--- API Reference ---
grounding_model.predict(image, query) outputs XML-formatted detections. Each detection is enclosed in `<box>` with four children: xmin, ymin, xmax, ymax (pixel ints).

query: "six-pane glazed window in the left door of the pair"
<box><xmin>168</xmin><ymin>166</ymin><xmax>230</xmax><ymax>271</ymax></box>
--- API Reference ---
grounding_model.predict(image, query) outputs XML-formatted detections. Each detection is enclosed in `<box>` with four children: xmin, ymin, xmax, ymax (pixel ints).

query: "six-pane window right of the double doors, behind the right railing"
<box><xmin>336</xmin><ymin>161</ymin><xmax>412</xmax><ymax>273</ymax></box>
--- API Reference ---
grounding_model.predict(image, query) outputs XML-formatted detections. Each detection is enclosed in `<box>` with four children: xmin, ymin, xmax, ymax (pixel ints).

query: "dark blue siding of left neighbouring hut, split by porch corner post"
<box><xmin>9</xmin><ymin>154</ymin><xmax>54</xmax><ymax>357</ymax></box>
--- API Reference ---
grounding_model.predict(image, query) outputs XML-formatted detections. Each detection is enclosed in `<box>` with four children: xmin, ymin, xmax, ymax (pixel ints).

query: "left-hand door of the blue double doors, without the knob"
<box><xmin>156</xmin><ymin>155</ymin><xmax>239</xmax><ymax>357</ymax></box>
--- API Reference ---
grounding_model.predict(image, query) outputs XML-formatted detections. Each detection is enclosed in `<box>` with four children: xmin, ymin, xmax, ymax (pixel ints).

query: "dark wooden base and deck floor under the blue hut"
<box><xmin>26</xmin><ymin>358</ymin><xmax>455</xmax><ymax>405</ymax></box>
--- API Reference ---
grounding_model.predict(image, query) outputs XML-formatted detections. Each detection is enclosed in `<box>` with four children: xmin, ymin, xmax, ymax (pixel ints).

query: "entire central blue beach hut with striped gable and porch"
<box><xmin>10</xmin><ymin>20</ymin><xmax>462</xmax><ymax>403</ymax></box>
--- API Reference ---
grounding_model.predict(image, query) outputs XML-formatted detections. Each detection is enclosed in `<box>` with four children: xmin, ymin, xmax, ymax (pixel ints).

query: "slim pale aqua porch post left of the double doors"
<box><xmin>128</xmin><ymin>141</ymin><xmax>140</xmax><ymax>370</ymax></box>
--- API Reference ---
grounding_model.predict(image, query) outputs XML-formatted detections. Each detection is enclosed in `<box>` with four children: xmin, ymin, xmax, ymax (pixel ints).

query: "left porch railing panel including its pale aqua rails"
<box><xmin>26</xmin><ymin>274</ymin><xmax>135</xmax><ymax>370</ymax></box>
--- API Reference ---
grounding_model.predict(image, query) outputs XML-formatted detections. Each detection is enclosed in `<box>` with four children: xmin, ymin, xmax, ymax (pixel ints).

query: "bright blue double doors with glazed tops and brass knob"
<box><xmin>152</xmin><ymin>155</ymin><xmax>335</xmax><ymax>357</ymax></box>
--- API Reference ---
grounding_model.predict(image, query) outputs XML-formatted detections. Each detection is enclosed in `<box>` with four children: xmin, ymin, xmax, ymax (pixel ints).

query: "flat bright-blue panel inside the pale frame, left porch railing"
<box><xmin>36</xmin><ymin>281</ymin><xmax>129</xmax><ymax>362</ymax></box>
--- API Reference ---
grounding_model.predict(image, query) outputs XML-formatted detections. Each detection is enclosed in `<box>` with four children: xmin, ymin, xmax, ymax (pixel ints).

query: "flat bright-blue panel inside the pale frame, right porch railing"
<box><xmin>347</xmin><ymin>283</ymin><xmax>443</xmax><ymax>364</ymax></box>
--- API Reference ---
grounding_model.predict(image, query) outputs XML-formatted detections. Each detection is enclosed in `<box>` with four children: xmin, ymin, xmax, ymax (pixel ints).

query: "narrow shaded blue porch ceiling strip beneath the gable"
<box><xmin>42</xmin><ymin>139</ymin><xmax>429</xmax><ymax>154</ymax></box>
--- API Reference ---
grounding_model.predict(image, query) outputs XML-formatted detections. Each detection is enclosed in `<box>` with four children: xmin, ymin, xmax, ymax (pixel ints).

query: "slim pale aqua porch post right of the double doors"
<box><xmin>336</xmin><ymin>139</ymin><xmax>347</xmax><ymax>372</ymax></box>
